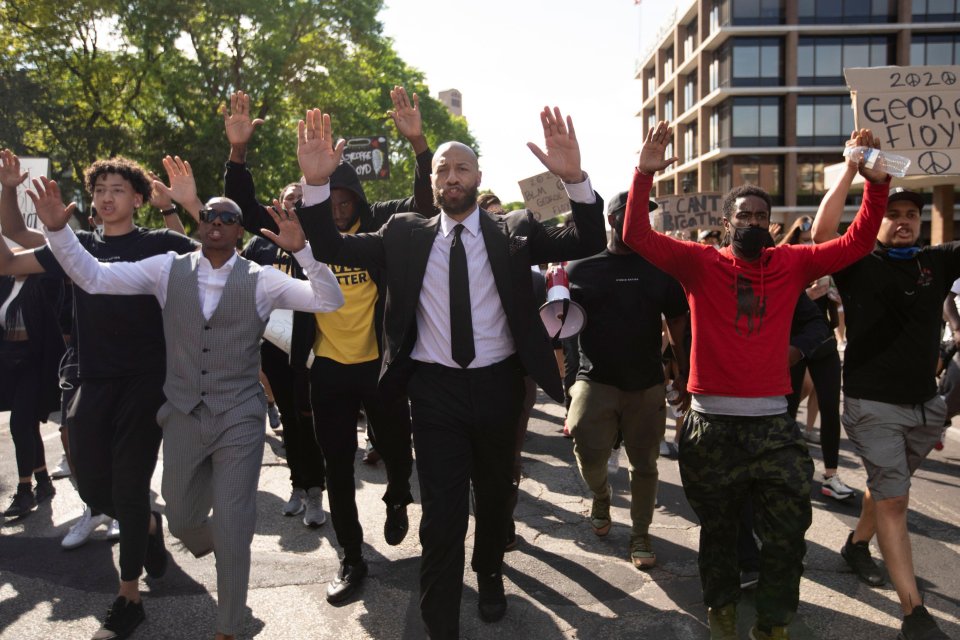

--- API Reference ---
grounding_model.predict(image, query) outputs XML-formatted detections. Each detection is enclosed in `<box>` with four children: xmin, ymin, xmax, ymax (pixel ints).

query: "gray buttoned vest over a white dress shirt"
<box><xmin>163</xmin><ymin>251</ymin><xmax>267</xmax><ymax>415</ymax></box>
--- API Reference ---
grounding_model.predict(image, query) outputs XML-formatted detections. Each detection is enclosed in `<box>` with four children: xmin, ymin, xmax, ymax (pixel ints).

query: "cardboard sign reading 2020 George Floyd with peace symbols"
<box><xmin>844</xmin><ymin>66</ymin><xmax>960</xmax><ymax>176</ymax></box>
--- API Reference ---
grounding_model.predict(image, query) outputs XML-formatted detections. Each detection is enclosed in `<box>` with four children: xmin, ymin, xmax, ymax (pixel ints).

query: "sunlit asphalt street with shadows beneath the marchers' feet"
<box><xmin>0</xmin><ymin>395</ymin><xmax>960</xmax><ymax>640</ymax></box>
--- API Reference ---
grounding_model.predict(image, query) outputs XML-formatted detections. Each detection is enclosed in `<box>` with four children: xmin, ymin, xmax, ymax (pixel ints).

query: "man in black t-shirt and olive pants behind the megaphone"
<box><xmin>567</xmin><ymin>192</ymin><xmax>687</xmax><ymax>569</ymax></box>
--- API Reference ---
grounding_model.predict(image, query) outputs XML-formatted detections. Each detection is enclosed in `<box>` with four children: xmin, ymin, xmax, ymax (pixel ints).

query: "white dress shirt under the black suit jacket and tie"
<box><xmin>303</xmin><ymin>174</ymin><xmax>596</xmax><ymax>369</ymax></box>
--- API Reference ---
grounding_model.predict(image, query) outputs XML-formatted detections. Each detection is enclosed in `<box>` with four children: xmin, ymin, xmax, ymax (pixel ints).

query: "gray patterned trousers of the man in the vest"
<box><xmin>157</xmin><ymin>394</ymin><xmax>266</xmax><ymax>635</ymax></box>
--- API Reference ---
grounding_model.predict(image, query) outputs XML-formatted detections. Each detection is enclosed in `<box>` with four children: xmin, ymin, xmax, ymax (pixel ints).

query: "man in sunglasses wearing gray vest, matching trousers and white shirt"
<box><xmin>34</xmin><ymin>179</ymin><xmax>343</xmax><ymax>640</ymax></box>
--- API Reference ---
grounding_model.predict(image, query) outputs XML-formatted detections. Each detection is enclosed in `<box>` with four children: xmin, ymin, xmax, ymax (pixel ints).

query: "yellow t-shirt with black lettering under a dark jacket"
<box><xmin>313</xmin><ymin>221</ymin><xmax>380</xmax><ymax>364</ymax></box>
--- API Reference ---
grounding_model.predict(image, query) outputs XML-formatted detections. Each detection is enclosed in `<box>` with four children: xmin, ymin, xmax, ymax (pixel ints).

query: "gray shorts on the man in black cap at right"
<box><xmin>842</xmin><ymin>396</ymin><xmax>947</xmax><ymax>500</ymax></box>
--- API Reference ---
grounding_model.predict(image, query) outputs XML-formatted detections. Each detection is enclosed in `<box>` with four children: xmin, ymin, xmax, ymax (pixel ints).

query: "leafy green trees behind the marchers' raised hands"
<box><xmin>0</xmin><ymin>0</ymin><xmax>476</xmax><ymax>225</ymax></box>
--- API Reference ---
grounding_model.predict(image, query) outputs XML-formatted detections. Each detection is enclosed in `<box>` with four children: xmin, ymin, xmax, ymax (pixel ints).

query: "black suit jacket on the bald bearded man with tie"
<box><xmin>297</xmin><ymin>194</ymin><xmax>607</xmax><ymax>402</ymax></box>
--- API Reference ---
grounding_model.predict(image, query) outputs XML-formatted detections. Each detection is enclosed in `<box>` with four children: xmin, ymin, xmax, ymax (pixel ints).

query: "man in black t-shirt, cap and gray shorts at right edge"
<box><xmin>813</xmin><ymin>166</ymin><xmax>960</xmax><ymax>640</ymax></box>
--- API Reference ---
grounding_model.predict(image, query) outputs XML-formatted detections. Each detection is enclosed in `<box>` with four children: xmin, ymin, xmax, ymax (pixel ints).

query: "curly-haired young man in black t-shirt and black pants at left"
<box><xmin>0</xmin><ymin>157</ymin><xmax>197</xmax><ymax>640</ymax></box>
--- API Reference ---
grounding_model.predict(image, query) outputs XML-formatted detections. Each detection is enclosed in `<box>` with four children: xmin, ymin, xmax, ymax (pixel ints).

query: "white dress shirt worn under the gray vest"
<box><xmin>45</xmin><ymin>227</ymin><xmax>343</xmax><ymax>320</ymax></box>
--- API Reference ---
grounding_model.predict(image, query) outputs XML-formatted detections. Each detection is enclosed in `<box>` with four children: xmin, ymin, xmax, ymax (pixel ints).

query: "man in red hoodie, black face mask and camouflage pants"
<box><xmin>624</xmin><ymin>122</ymin><xmax>889</xmax><ymax>640</ymax></box>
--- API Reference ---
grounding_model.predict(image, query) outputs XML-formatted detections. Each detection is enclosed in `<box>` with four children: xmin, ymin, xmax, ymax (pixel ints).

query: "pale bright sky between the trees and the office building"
<box><xmin>380</xmin><ymin>0</ymin><xmax>690</xmax><ymax>202</ymax></box>
